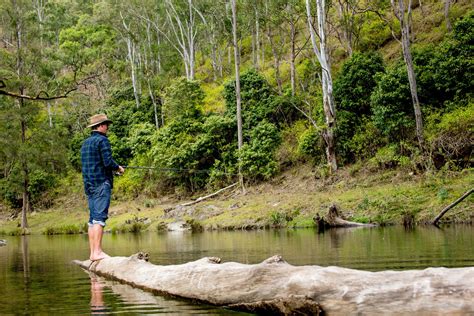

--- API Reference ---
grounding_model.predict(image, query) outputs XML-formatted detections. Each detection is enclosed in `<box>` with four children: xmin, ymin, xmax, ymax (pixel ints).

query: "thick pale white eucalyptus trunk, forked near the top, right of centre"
<box><xmin>306</xmin><ymin>0</ymin><xmax>337</xmax><ymax>172</ymax></box>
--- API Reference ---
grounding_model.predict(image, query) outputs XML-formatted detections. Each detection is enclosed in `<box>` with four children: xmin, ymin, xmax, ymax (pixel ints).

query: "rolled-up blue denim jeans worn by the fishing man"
<box><xmin>87</xmin><ymin>181</ymin><xmax>112</xmax><ymax>227</ymax></box>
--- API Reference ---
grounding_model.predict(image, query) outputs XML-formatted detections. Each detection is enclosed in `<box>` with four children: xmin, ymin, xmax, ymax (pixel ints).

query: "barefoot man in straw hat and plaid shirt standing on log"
<box><xmin>81</xmin><ymin>114</ymin><xmax>124</xmax><ymax>261</ymax></box>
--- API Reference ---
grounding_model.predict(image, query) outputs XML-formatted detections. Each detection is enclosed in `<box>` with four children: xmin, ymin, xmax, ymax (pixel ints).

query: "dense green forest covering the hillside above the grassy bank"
<box><xmin>0</xmin><ymin>0</ymin><xmax>474</xmax><ymax>228</ymax></box>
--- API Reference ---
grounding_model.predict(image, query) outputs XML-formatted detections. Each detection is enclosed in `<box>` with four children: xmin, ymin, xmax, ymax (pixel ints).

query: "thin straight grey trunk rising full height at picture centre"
<box><xmin>232</xmin><ymin>0</ymin><xmax>245</xmax><ymax>191</ymax></box>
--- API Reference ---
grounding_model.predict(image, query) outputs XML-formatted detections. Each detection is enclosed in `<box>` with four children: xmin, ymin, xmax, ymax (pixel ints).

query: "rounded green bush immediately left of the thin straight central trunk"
<box><xmin>150</xmin><ymin>115</ymin><xmax>236</xmax><ymax>190</ymax></box>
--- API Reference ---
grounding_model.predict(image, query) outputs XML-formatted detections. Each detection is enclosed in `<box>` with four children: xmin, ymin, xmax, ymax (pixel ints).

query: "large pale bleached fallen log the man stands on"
<box><xmin>74</xmin><ymin>254</ymin><xmax>474</xmax><ymax>315</ymax></box>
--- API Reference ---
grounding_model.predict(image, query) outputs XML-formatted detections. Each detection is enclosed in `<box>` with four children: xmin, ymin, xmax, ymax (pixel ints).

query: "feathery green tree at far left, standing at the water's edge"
<box><xmin>0</xmin><ymin>0</ymin><xmax>71</xmax><ymax>229</ymax></box>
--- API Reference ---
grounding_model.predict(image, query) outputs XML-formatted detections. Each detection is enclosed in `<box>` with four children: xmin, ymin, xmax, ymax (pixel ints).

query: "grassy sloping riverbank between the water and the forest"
<box><xmin>0</xmin><ymin>165</ymin><xmax>474</xmax><ymax>235</ymax></box>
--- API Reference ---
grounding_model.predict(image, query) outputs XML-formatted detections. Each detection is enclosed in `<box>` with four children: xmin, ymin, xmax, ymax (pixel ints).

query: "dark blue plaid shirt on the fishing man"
<box><xmin>81</xmin><ymin>131</ymin><xmax>119</xmax><ymax>195</ymax></box>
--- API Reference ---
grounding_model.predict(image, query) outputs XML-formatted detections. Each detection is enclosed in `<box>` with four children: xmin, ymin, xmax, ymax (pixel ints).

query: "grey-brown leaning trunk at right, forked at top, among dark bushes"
<box><xmin>391</xmin><ymin>0</ymin><xmax>425</xmax><ymax>149</ymax></box>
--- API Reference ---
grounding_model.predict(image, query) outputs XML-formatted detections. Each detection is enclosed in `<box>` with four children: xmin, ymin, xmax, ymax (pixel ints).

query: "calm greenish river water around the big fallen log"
<box><xmin>0</xmin><ymin>225</ymin><xmax>474</xmax><ymax>315</ymax></box>
